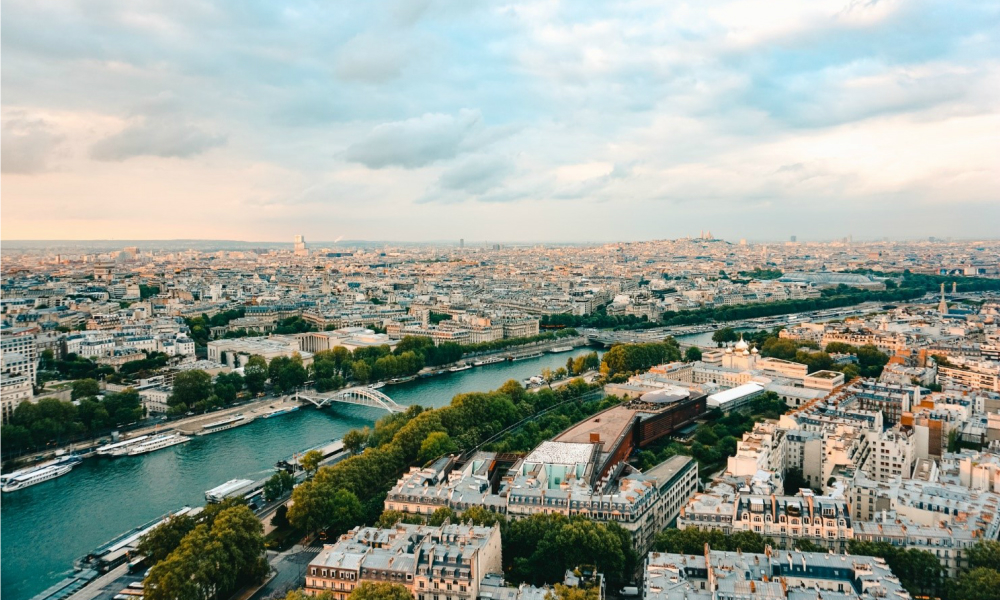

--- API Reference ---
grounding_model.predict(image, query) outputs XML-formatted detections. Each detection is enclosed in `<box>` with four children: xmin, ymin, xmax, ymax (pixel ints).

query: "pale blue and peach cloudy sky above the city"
<box><xmin>0</xmin><ymin>0</ymin><xmax>1000</xmax><ymax>241</ymax></box>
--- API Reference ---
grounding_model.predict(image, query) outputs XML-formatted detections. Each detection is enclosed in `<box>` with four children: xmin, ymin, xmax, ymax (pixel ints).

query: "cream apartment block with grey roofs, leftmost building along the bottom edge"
<box><xmin>305</xmin><ymin>523</ymin><xmax>503</xmax><ymax>600</ymax></box>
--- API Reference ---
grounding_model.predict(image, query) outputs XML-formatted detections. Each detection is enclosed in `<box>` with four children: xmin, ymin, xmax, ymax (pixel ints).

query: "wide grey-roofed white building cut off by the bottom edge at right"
<box><xmin>643</xmin><ymin>545</ymin><xmax>910</xmax><ymax>600</ymax></box>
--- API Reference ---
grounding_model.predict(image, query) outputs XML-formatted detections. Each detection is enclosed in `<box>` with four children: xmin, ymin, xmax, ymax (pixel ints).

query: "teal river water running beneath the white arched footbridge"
<box><xmin>0</xmin><ymin>348</ymin><xmax>593</xmax><ymax>600</ymax></box>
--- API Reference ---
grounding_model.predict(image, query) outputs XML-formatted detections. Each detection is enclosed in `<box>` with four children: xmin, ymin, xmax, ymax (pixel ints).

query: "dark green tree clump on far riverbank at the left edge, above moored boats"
<box><xmin>0</xmin><ymin>386</ymin><xmax>145</xmax><ymax>454</ymax></box>
